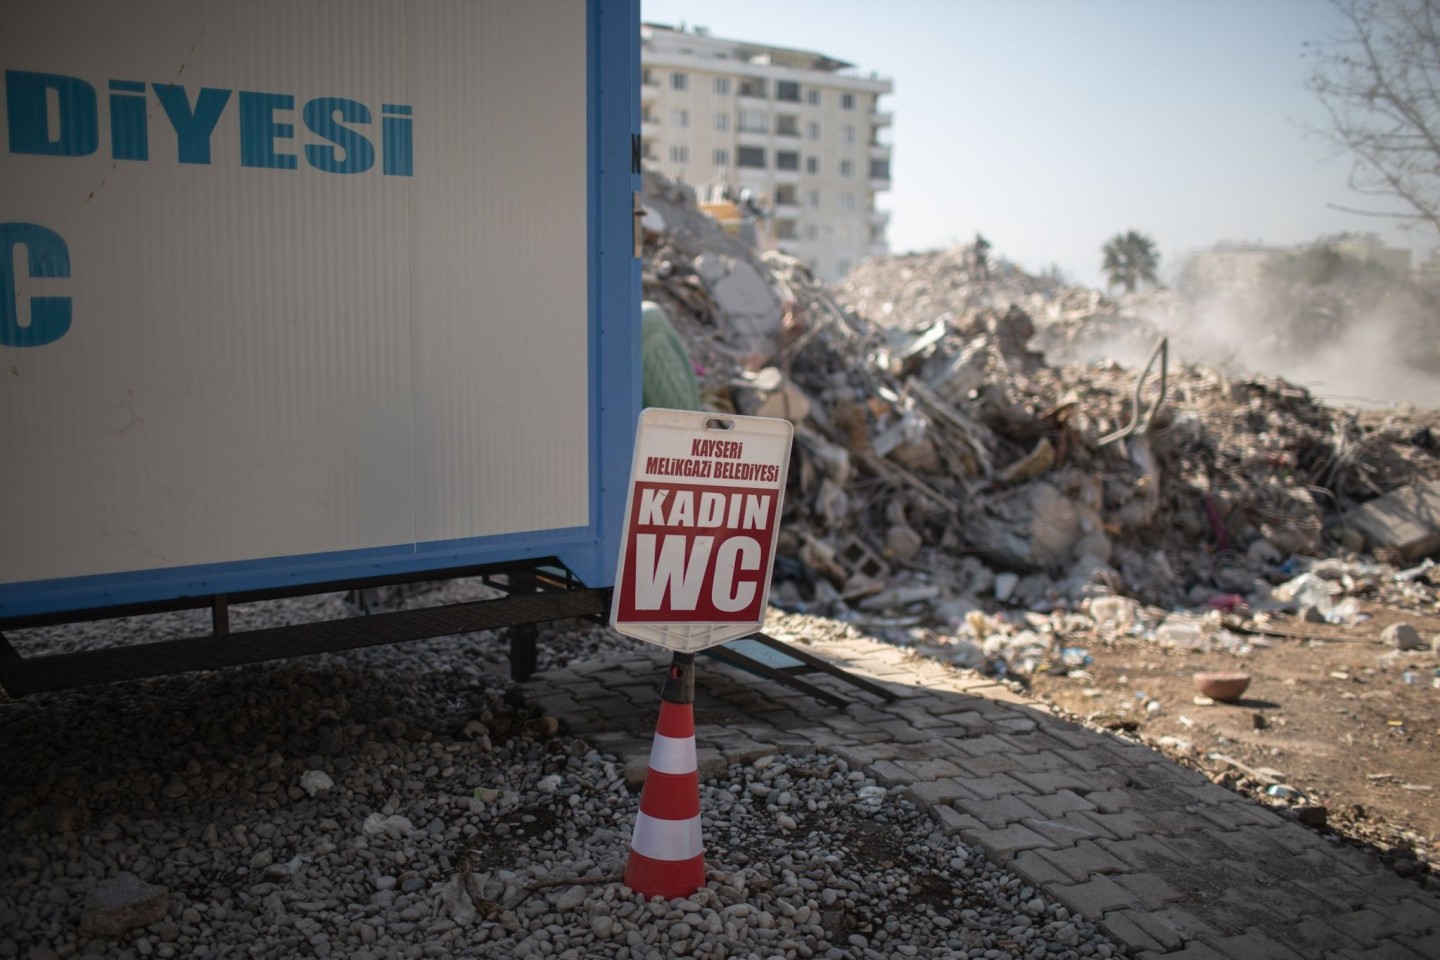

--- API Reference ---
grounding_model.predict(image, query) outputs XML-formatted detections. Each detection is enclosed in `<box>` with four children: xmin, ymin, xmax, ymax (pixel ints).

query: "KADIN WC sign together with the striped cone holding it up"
<box><xmin>611</xmin><ymin>409</ymin><xmax>793</xmax><ymax>900</ymax></box>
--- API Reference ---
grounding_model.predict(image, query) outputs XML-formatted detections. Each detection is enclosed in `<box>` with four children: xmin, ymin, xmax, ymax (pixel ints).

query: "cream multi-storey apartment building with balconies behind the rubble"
<box><xmin>641</xmin><ymin>23</ymin><xmax>894</xmax><ymax>281</ymax></box>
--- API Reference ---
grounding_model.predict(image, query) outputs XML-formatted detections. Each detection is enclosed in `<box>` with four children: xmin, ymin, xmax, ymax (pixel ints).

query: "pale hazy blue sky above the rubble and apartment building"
<box><xmin>641</xmin><ymin>0</ymin><xmax>1433</xmax><ymax>285</ymax></box>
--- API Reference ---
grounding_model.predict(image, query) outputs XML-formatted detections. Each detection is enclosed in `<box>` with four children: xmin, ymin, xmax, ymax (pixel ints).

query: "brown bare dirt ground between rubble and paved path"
<box><xmin>1030</xmin><ymin>604</ymin><xmax>1440</xmax><ymax>877</ymax></box>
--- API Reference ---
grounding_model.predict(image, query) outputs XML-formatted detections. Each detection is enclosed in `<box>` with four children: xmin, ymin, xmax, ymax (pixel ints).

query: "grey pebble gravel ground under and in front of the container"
<box><xmin>0</xmin><ymin>596</ymin><xmax>1123</xmax><ymax>960</ymax></box>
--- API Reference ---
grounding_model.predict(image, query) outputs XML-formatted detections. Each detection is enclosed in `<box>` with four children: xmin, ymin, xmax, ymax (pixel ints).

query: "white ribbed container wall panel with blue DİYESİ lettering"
<box><xmin>0</xmin><ymin>0</ymin><xmax>595</xmax><ymax>601</ymax></box>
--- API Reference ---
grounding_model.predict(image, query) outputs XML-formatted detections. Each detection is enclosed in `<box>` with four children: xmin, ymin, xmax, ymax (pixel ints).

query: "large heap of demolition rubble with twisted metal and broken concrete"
<box><xmin>642</xmin><ymin>174</ymin><xmax>1440</xmax><ymax>682</ymax></box>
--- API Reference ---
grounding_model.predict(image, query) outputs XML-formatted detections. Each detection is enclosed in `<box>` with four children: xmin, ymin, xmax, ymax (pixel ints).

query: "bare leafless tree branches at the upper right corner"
<box><xmin>1308</xmin><ymin>0</ymin><xmax>1440</xmax><ymax>232</ymax></box>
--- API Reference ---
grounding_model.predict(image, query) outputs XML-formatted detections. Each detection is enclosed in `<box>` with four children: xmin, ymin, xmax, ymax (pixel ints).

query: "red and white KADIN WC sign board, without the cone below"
<box><xmin>611</xmin><ymin>409</ymin><xmax>793</xmax><ymax>652</ymax></box>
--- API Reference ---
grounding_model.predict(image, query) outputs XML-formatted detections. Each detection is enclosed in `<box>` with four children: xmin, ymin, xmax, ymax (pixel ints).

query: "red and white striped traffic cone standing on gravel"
<box><xmin>625</xmin><ymin>653</ymin><xmax>706</xmax><ymax>900</ymax></box>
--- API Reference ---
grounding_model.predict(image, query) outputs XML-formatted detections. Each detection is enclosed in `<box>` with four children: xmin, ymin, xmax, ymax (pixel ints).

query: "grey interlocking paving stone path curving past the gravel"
<box><xmin>526</xmin><ymin>639</ymin><xmax>1440</xmax><ymax>960</ymax></box>
